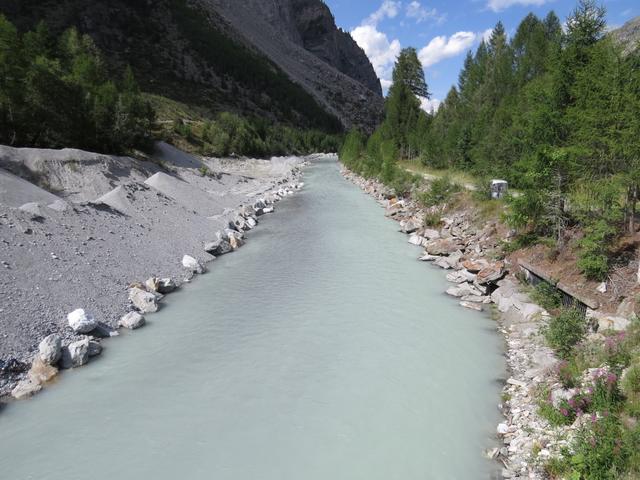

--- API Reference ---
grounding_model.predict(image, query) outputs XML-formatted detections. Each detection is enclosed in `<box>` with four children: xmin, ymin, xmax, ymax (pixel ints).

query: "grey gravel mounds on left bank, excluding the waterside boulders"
<box><xmin>0</xmin><ymin>144</ymin><xmax>302</xmax><ymax>396</ymax></box>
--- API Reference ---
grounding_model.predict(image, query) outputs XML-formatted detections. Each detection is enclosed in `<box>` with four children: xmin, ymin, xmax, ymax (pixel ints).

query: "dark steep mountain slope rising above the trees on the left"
<box><xmin>0</xmin><ymin>0</ymin><xmax>383</xmax><ymax>131</ymax></box>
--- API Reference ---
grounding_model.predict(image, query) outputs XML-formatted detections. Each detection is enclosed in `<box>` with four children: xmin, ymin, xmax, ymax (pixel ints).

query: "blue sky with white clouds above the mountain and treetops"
<box><xmin>325</xmin><ymin>0</ymin><xmax>640</xmax><ymax>111</ymax></box>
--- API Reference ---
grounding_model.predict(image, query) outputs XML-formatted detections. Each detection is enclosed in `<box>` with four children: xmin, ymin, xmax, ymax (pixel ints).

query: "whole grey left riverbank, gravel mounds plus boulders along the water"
<box><xmin>0</xmin><ymin>144</ymin><xmax>314</xmax><ymax>398</ymax></box>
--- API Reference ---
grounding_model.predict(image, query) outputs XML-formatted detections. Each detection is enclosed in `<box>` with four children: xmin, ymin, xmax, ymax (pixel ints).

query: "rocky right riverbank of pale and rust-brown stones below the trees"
<box><xmin>343</xmin><ymin>170</ymin><xmax>575</xmax><ymax>479</ymax></box>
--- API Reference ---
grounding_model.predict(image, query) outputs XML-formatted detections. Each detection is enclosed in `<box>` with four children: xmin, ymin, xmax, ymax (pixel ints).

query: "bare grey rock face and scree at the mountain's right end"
<box><xmin>206</xmin><ymin>0</ymin><xmax>383</xmax><ymax>130</ymax></box>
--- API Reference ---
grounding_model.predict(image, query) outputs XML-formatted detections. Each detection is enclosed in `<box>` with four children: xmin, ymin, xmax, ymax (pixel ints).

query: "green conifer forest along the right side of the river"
<box><xmin>342</xmin><ymin>0</ymin><xmax>640</xmax><ymax>280</ymax></box>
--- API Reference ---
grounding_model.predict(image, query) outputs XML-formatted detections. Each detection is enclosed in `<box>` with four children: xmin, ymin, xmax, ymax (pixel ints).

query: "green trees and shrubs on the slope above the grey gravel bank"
<box><xmin>0</xmin><ymin>15</ymin><xmax>339</xmax><ymax>156</ymax></box>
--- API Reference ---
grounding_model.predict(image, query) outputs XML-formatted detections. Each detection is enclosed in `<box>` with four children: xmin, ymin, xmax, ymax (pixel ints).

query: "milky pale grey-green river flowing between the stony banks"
<box><xmin>0</xmin><ymin>159</ymin><xmax>505</xmax><ymax>480</ymax></box>
